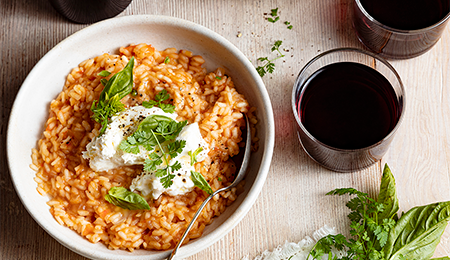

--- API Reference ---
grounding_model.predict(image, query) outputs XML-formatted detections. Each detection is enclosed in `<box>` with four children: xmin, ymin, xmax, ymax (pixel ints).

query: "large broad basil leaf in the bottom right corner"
<box><xmin>383</xmin><ymin>201</ymin><xmax>450</xmax><ymax>260</ymax></box>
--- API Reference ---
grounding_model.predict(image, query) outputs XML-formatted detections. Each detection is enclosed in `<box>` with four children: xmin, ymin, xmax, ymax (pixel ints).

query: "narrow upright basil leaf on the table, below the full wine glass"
<box><xmin>378</xmin><ymin>164</ymin><xmax>399</xmax><ymax>221</ymax></box>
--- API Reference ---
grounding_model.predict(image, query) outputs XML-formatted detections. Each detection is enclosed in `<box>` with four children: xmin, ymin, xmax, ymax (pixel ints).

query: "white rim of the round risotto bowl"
<box><xmin>6</xmin><ymin>15</ymin><xmax>275</xmax><ymax>259</ymax></box>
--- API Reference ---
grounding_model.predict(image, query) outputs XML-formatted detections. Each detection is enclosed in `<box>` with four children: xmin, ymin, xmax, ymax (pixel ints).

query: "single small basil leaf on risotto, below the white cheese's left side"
<box><xmin>105</xmin><ymin>187</ymin><xmax>150</xmax><ymax>210</ymax></box>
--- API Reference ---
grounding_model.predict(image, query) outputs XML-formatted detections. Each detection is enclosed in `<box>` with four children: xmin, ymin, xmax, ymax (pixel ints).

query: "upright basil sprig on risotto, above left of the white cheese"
<box><xmin>91</xmin><ymin>57</ymin><xmax>134</xmax><ymax>135</ymax></box>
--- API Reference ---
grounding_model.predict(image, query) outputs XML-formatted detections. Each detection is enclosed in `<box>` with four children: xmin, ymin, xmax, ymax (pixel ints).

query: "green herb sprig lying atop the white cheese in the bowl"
<box><xmin>119</xmin><ymin>115</ymin><xmax>187</xmax><ymax>154</ymax></box>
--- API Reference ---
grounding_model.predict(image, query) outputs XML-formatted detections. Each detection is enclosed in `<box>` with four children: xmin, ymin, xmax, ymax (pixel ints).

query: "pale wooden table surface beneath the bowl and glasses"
<box><xmin>0</xmin><ymin>0</ymin><xmax>450</xmax><ymax>260</ymax></box>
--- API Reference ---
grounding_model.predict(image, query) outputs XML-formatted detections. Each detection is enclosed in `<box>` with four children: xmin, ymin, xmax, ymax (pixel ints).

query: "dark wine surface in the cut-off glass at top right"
<box><xmin>360</xmin><ymin>0</ymin><xmax>450</xmax><ymax>30</ymax></box>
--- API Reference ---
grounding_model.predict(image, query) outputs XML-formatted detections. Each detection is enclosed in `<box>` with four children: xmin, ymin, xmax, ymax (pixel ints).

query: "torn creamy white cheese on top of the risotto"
<box><xmin>82</xmin><ymin>106</ymin><xmax>209</xmax><ymax>199</ymax></box>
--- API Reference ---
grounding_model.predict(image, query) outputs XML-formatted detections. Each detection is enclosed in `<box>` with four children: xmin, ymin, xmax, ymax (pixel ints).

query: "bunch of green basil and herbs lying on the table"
<box><xmin>307</xmin><ymin>165</ymin><xmax>450</xmax><ymax>260</ymax></box>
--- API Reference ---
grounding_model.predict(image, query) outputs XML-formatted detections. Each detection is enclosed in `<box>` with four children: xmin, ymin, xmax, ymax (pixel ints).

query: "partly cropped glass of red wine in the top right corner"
<box><xmin>353</xmin><ymin>0</ymin><xmax>450</xmax><ymax>59</ymax></box>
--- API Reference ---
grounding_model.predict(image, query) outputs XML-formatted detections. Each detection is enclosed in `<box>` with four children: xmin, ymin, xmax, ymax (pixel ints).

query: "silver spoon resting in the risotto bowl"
<box><xmin>167</xmin><ymin>114</ymin><xmax>252</xmax><ymax>260</ymax></box>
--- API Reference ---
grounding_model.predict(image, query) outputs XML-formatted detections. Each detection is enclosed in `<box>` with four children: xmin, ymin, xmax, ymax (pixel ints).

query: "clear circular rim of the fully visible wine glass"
<box><xmin>291</xmin><ymin>48</ymin><xmax>406</xmax><ymax>152</ymax></box>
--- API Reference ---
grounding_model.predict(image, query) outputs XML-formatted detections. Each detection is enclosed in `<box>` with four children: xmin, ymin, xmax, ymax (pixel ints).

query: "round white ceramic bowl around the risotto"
<box><xmin>7</xmin><ymin>15</ymin><xmax>275</xmax><ymax>260</ymax></box>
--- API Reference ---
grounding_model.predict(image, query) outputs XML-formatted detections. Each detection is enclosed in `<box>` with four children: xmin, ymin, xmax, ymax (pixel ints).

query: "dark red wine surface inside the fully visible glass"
<box><xmin>298</xmin><ymin>62</ymin><xmax>400</xmax><ymax>149</ymax></box>
